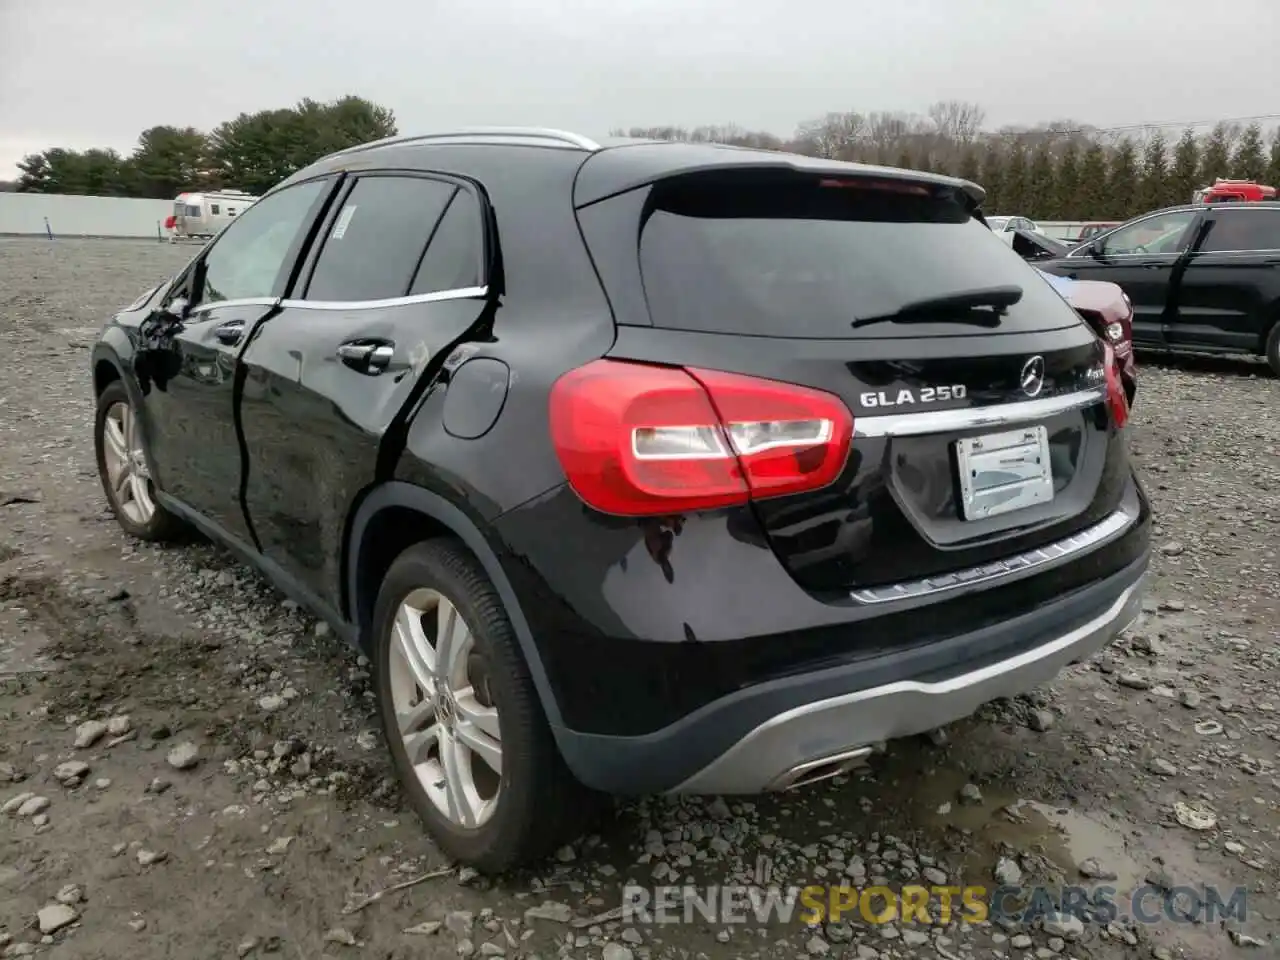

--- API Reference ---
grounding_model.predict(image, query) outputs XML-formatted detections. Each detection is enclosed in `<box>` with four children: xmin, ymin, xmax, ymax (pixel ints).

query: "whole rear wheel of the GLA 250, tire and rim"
<box><xmin>371</xmin><ymin>539</ymin><xmax>594</xmax><ymax>873</ymax></box>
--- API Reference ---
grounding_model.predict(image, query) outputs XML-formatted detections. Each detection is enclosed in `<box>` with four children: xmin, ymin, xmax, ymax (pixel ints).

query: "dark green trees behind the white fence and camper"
<box><xmin>7</xmin><ymin>96</ymin><xmax>396</xmax><ymax>200</ymax></box>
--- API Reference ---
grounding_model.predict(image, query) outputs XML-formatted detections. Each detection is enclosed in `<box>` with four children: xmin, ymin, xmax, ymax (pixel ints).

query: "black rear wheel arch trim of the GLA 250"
<box><xmin>343</xmin><ymin>480</ymin><xmax>562</xmax><ymax>739</ymax></box>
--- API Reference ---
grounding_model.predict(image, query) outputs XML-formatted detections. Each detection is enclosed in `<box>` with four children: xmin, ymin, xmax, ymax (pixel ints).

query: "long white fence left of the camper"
<box><xmin>0</xmin><ymin>193</ymin><xmax>173</xmax><ymax>239</ymax></box>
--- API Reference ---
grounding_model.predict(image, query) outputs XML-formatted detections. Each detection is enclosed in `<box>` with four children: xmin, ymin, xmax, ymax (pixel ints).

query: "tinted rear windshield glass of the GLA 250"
<box><xmin>640</xmin><ymin>174</ymin><xmax>1079</xmax><ymax>338</ymax></box>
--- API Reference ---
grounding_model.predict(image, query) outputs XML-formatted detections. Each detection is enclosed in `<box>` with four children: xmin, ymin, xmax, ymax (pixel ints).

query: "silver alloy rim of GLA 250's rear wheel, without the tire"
<box><xmin>389</xmin><ymin>588</ymin><xmax>502</xmax><ymax>829</ymax></box>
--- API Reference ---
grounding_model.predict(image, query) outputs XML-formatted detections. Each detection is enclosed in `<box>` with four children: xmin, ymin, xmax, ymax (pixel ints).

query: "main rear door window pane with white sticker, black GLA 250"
<box><xmin>306</xmin><ymin>177</ymin><xmax>457</xmax><ymax>302</ymax></box>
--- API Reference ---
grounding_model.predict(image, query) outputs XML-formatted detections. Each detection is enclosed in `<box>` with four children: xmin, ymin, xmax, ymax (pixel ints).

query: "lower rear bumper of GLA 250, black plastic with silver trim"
<box><xmin>556</xmin><ymin>549</ymin><xmax>1149</xmax><ymax>794</ymax></box>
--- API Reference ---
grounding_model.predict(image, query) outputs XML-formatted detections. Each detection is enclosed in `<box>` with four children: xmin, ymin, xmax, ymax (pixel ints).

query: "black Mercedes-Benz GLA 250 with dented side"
<box><xmin>92</xmin><ymin>128</ymin><xmax>1151</xmax><ymax>870</ymax></box>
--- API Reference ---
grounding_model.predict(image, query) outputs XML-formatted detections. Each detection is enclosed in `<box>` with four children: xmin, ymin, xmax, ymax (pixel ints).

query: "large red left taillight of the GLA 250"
<box><xmin>550</xmin><ymin>360</ymin><xmax>854</xmax><ymax>516</ymax></box>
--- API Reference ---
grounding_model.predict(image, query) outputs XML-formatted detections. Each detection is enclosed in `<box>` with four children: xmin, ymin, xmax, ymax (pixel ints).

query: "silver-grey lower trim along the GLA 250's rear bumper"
<box><xmin>669</xmin><ymin>577</ymin><xmax>1146</xmax><ymax>794</ymax></box>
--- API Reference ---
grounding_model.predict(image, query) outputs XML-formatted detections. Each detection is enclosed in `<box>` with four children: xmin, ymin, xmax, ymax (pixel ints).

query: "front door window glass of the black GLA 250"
<box><xmin>200</xmin><ymin>180</ymin><xmax>330</xmax><ymax>303</ymax></box>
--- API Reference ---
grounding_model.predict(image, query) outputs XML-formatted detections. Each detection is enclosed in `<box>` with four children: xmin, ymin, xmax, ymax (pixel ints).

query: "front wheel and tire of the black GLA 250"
<box><xmin>93</xmin><ymin>380</ymin><xmax>191</xmax><ymax>543</ymax></box>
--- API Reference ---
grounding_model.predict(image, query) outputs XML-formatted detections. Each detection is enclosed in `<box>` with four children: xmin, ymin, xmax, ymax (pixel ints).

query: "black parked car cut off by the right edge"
<box><xmin>1037</xmin><ymin>202</ymin><xmax>1280</xmax><ymax>375</ymax></box>
